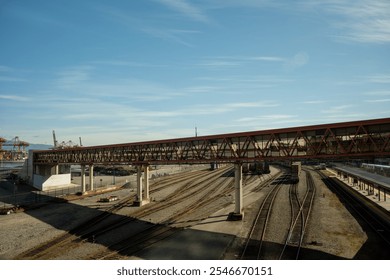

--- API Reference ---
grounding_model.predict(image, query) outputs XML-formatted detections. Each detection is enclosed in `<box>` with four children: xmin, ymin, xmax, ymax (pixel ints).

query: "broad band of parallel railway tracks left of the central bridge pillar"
<box><xmin>17</xmin><ymin>167</ymin><xmax>262</xmax><ymax>259</ymax></box>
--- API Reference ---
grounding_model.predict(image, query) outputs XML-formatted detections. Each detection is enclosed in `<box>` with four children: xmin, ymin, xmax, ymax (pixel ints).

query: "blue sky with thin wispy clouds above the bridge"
<box><xmin>0</xmin><ymin>0</ymin><xmax>390</xmax><ymax>145</ymax></box>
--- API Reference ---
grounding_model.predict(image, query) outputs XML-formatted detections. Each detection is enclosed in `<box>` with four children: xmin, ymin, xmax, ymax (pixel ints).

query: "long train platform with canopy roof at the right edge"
<box><xmin>327</xmin><ymin>165</ymin><xmax>390</xmax><ymax>211</ymax></box>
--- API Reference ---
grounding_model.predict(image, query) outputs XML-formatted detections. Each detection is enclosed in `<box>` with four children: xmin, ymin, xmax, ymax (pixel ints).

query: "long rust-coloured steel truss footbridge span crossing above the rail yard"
<box><xmin>33</xmin><ymin>118</ymin><xmax>390</xmax><ymax>164</ymax></box>
